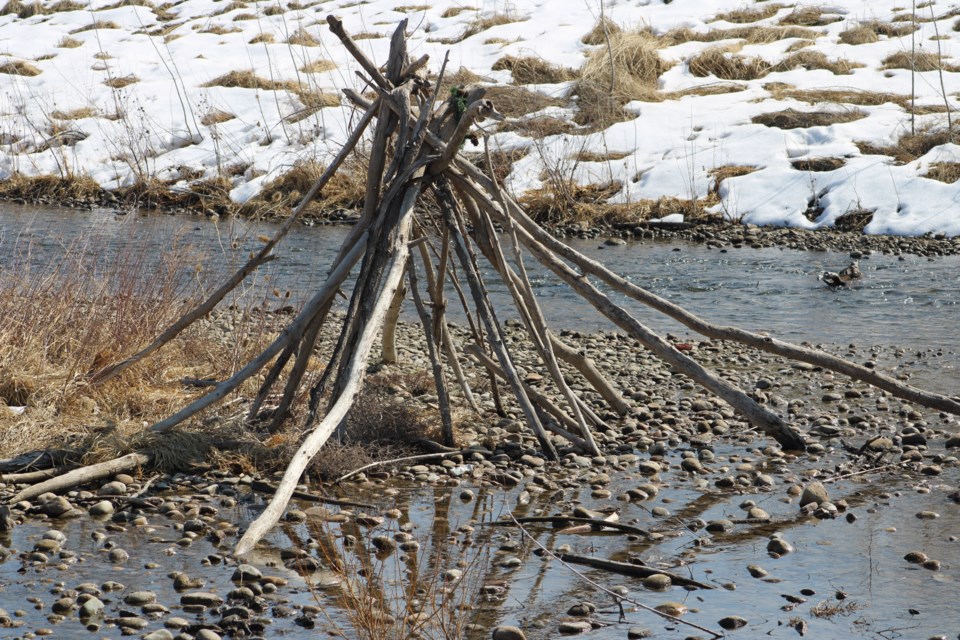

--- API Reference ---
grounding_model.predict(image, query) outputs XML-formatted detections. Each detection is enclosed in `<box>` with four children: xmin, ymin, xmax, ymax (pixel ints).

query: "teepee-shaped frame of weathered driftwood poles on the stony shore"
<box><xmin>26</xmin><ymin>16</ymin><xmax>960</xmax><ymax>556</ymax></box>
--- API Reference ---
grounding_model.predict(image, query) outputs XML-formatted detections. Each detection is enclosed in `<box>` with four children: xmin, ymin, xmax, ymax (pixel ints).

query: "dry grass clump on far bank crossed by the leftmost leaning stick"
<box><xmin>243</xmin><ymin>156</ymin><xmax>367</xmax><ymax>218</ymax></box>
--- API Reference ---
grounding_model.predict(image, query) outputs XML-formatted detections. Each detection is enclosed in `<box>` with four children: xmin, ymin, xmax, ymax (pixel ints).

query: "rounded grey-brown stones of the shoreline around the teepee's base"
<box><xmin>0</xmin><ymin>324</ymin><xmax>960</xmax><ymax>640</ymax></box>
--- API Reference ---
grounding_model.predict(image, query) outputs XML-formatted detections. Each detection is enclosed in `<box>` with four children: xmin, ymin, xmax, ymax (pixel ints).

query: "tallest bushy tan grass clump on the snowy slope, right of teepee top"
<box><xmin>574</xmin><ymin>31</ymin><xmax>670</xmax><ymax>128</ymax></box>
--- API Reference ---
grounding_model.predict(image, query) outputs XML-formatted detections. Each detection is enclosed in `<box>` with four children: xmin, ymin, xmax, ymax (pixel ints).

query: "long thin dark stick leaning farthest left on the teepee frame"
<box><xmin>90</xmin><ymin>99</ymin><xmax>380</xmax><ymax>384</ymax></box>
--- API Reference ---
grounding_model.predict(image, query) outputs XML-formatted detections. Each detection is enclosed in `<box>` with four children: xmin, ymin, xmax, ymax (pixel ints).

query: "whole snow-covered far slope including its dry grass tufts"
<box><xmin>0</xmin><ymin>0</ymin><xmax>960</xmax><ymax>235</ymax></box>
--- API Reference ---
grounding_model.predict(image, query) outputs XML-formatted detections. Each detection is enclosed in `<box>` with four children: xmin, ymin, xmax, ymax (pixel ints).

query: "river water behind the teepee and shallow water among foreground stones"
<box><xmin>0</xmin><ymin>206</ymin><xmax>960</xmax><ymax>640</ymax></box>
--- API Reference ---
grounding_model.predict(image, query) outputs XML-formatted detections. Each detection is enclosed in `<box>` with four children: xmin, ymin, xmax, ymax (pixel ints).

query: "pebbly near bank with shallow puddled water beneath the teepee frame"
<box><xmin>0</xmin><ymin>323</ymin><xmax>960</xmax><ymax>640</ymax></box>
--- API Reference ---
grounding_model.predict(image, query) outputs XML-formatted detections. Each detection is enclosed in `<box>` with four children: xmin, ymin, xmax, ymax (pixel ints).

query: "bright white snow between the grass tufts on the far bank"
<box><xmin>0</xmin><ymin>0</ymin><xmax>960</xmax><ymax>236</ymax></box>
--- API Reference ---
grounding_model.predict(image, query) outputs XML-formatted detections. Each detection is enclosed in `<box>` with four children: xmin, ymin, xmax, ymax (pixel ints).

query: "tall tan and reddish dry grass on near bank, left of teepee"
<box><xmin>0</xmin><ymin>232</ymin><xmax>227</xmax><ymax>457</ymax></box>
